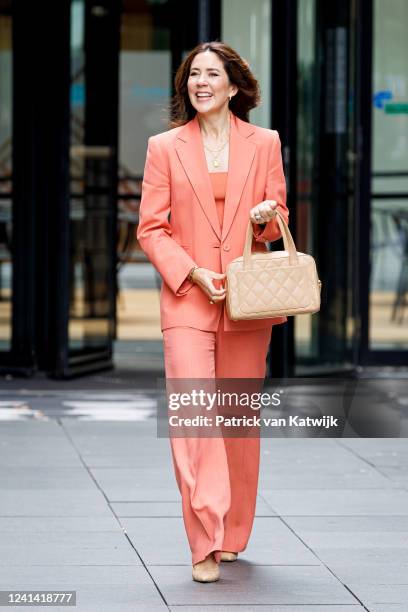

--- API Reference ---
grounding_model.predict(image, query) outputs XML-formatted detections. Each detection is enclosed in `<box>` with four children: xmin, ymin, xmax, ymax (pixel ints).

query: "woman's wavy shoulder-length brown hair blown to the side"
<box><xmin>169</xmin><ymin>41</ymin><xmax>261</xmax><ymax>128</ymax></box>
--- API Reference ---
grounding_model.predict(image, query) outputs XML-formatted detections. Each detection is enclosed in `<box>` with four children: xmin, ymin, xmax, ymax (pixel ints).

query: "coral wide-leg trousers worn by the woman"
<box><xmin>163</xmin><ymin>317</ymin><xmax>272</xmax><ymax>565</ymax></box>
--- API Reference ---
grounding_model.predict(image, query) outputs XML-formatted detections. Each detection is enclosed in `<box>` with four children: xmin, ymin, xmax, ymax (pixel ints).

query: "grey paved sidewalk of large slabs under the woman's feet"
<box><xmin>0</xmin><ymin>373</ymin><xmax>408</xmax><ymax>612</ymax></box>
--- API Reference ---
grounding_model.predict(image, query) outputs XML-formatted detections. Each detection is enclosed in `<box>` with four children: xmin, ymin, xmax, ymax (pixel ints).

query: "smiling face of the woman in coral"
<box><xmin>187</xmin><ymin>50</ymin><xmax>238</xmax><ymax>114</ymax></box>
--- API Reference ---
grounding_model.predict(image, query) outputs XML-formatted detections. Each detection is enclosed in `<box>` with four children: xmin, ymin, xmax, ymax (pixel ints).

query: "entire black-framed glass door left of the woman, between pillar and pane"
<box><xmin>65</xmin><ymin>0</ymin><xmax>119</xmax><ymax>372</ymax></box>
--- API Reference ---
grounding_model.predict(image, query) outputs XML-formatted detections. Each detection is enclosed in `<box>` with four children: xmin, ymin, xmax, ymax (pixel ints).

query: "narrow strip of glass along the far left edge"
<box><xmin>0</xmin><ymin>1</ymin><xmax>13</xmax><ymax>351</ymax></box>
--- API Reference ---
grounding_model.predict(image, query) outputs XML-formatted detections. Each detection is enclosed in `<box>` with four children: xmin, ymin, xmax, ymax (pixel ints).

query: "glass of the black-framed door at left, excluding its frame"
<box><xmin>69</xmin><ymin>0</ymin><xmax>111</xmax><ymax>354</ymax></box>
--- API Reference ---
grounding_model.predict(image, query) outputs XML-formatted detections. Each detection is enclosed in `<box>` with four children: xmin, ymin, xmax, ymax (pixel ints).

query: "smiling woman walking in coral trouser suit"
<box><xmin>137</xmin><ymin>42</ymin><xmax>288</xmax><ymax>582</ymax></box>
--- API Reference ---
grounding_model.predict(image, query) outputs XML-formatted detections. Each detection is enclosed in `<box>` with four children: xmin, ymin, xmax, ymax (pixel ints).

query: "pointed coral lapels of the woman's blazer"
<box><xmin>175</xmin><ymin>113</ymin><xmax>256</xmax><ymax>240</ymax></box>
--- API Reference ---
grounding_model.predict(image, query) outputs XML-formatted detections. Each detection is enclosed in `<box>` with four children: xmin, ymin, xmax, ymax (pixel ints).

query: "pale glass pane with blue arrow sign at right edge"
<box><xmin>369</xmin><ymin>0</ymin><xmax>408</xmax><ymax>350</ymax></box>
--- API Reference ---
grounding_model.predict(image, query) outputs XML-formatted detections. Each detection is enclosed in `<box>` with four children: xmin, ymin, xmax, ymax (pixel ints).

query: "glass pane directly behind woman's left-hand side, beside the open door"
<box><xmin>117</xmin><ymin>0</ymin><xmax>174</xmax><ymax>344</ymax></box>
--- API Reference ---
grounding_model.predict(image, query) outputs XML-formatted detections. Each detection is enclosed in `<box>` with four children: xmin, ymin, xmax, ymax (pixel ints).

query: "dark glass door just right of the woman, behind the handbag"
<box><xmin>292</xmin><ymin>0</ymin><xmax>357</xmax><ymax>376</ymax></box>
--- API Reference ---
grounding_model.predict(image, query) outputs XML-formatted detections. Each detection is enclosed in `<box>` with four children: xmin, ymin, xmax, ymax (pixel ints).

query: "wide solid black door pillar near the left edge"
<box><xmin>0</xmin><ymin>0</ymin><xmax>69</xmax><ymax>376</ymax></box>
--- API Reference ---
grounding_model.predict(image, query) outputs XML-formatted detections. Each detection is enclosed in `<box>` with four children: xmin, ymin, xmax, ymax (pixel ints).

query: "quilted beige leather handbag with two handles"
<box><xmin>226</xmin><ymin>210</ymin><xmax>321</xmax><ymax>321</ymax></box>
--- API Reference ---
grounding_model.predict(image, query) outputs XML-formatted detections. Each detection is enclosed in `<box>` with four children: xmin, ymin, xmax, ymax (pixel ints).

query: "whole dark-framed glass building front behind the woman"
<box><xmin>0</xmin><ymin>0</ymin><xmax>408</xmax><ymax>376</ymax></box>
